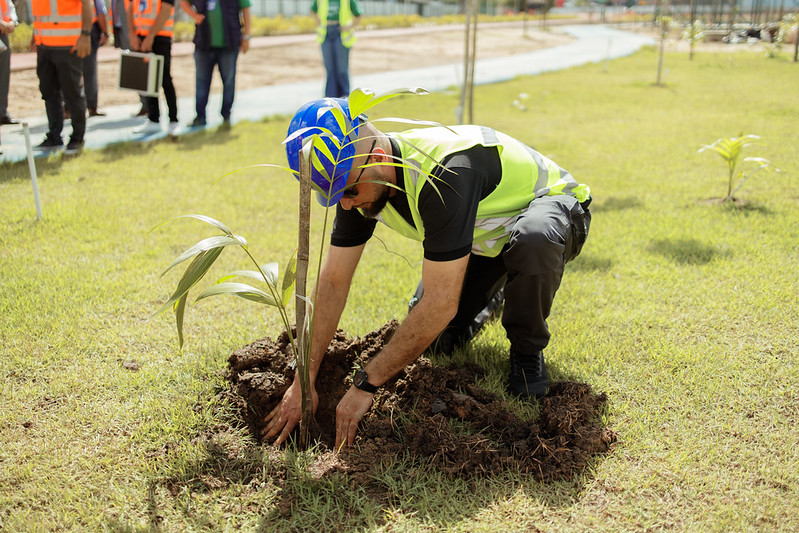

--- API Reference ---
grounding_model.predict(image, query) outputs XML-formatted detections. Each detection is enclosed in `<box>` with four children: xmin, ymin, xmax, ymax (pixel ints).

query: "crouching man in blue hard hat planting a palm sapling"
<box><xmin>264</xmin><ymin>99</ymin><xmax>591</xmax><ymax>449</ymax></box>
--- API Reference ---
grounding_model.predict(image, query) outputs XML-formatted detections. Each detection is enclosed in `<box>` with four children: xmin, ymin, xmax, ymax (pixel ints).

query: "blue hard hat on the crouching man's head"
<box><xmin>285</xmin><ymin>98</ymin><xmax>360</xmax><ymax>207</ymax></box>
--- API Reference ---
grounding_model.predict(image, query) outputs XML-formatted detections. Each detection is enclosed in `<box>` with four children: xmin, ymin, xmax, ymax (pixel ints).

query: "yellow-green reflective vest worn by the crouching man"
<box><xmin>378</xmin><ymin>126</ymin><xmax>590</xmax><ymax>257</ymax></box>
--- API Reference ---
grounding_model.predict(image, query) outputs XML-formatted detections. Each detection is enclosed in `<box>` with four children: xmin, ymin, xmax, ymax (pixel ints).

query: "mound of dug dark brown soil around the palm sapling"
<box><xmin>228</xmin><ymin>322</ymin><xmax>616</xmax><ymax>481</ymax></box>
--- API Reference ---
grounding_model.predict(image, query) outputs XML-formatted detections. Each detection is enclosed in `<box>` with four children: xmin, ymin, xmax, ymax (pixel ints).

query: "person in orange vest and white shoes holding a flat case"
<box><xmin>127</xmin><ymin>0</ymin><xmax>179</xmax><ymax>135</ymax></box>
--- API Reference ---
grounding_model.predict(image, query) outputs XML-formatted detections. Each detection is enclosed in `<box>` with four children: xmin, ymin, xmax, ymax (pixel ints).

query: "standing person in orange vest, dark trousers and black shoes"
<box><xmin>31</xmin><ymin>0</ymin><xmax>93</xmax><ymax>154</ymax></box>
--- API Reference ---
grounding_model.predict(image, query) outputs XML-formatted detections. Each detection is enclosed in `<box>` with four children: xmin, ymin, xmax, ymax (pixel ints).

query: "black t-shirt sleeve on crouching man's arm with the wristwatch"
<box><xmin>419</xmin><ymin>145</ymin><xmax>502</xmax><ymax>261</ymax></box>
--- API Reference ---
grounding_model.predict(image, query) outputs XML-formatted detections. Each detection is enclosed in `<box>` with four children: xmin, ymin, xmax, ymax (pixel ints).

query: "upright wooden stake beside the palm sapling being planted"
<box><xmin>295</xmin><ymin>143</ymin><xmax>313</xmax><ymax>449</ymax></box>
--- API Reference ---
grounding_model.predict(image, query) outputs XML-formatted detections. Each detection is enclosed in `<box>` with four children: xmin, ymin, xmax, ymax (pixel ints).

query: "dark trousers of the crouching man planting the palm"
<box><xmin>417</xmin><ymin>195</ymin><xmax>591</xmax><ymax>354</ymax></box>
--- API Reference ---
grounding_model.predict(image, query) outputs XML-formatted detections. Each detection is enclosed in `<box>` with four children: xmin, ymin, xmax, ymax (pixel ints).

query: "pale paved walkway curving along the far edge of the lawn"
<box><xmin>0</xmin><ymin>25</ymin><xmax>654</xmax><ymax>161</ymax></box>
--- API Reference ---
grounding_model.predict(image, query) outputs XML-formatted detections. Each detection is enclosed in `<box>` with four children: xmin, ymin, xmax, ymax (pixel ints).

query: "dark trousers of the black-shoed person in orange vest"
<box><xmin>36</xmin><ymin>45</ymin><xmax>86</xmax><ymax>142</ymax></box>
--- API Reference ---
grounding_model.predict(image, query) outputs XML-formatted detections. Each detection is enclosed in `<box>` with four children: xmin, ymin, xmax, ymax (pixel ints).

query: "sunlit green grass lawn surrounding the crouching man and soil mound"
<box><xmin>0</xmin><ymin>44</ymin><xmax>799</xmax><ymax>532</ymax></box>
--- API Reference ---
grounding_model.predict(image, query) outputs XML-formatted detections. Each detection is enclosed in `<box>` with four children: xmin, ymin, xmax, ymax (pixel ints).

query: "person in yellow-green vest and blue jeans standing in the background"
<box><xmin>311</xmin><ymin>0</ymin><xmax>361</xmax><ymax>98</ymax></box>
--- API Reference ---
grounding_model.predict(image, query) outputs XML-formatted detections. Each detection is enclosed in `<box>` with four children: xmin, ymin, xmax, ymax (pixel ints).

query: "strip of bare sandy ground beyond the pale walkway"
<box><xmin>9</xmin><ymin>25</ymin><xmax>572</xmax><ymax>117</ymax></box>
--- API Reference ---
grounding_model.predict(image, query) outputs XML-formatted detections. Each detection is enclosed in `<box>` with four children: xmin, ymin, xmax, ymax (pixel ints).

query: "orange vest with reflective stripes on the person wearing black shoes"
<box><xmin>31</xmin><ymin>0</ymin><xmax>83</xmax><ymax>47</ymax></box>
